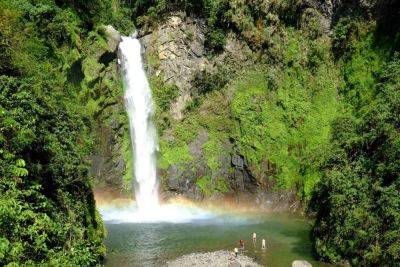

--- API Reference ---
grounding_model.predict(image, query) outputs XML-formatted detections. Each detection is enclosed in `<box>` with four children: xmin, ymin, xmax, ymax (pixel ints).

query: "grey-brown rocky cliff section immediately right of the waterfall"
<box><xmin>141</xmin><ymin>13</ymin><xmax>297</xmax><ymax>211</ymax></box>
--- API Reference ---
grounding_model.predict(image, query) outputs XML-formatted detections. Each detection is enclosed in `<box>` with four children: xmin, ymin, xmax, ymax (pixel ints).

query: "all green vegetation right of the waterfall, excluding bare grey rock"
<box><xmin>135</xmin><ymin>0</ymin><xmax>400</xmax><ymax>266</ymax></box>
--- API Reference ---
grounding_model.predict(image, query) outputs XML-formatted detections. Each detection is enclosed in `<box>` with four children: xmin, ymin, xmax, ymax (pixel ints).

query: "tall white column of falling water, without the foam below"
<box><xmin>119</xmin><ymin>37</ymin><xmax>159</xmax><ymax>211</ymax></box>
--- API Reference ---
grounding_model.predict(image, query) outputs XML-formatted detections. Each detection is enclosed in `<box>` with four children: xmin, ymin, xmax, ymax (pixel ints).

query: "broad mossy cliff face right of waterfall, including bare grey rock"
<box><xmin>142</xmin><ymin>2</ymin><xmax>340</xmax><ymax>205</ymax></box>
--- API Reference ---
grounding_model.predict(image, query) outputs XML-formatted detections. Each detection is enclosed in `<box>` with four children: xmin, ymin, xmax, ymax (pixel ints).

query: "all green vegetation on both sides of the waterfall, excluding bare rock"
<box><xmin>0</xmin><ymin>0</ymin><xmax>400</xmax><ymax>266</ymax></box>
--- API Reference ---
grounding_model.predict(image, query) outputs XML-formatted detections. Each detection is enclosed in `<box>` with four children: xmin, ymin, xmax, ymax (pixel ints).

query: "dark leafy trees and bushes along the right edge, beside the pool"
<box><xmin>311</xmin><ymin>22</ymin><xmax>400</xmax><ymax>266</ymax></box>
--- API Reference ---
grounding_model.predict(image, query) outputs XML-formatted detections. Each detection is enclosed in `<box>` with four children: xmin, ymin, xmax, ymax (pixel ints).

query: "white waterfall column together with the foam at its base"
<box><xmin>100</xmin><ymin>36</ymin><xmax>214</xmax><ymax>223</ymax></box>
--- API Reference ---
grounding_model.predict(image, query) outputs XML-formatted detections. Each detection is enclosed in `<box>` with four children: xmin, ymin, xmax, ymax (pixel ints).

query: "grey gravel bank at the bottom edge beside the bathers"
<box><xmin>167</xmin><ymin>250</ymin><xmax>261</xmax><ymax>267</ymax></box>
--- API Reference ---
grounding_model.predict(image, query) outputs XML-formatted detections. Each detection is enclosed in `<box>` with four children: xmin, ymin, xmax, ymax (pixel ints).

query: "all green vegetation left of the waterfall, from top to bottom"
<box><xmin>0</xmin><ymin>0</ymin><xmax>132</xmax><ymax>266</ymax></box>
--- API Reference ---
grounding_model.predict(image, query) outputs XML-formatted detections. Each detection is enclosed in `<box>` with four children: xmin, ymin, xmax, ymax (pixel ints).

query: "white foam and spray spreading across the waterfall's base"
<box><xmin>99</xmin><ymin>202</ymin><xmax>255</xmax><ymax>224</ymax></box>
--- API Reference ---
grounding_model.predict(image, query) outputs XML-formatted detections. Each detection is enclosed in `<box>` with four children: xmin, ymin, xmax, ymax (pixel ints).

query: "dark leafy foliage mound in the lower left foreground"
<box><xmin>0</xmin><ymin>76</ymin><xmax>105</xmax><ymax>265</ymax></box>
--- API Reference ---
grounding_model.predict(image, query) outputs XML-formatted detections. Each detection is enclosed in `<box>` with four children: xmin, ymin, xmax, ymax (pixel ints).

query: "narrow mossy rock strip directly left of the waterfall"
<box><xmin>80</xmin><ymin>29</ymin><xmax>129</xmax><ymax>195</ymax></box>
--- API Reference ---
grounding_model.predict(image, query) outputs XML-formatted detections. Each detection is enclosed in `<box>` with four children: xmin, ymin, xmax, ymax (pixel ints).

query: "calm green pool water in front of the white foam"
<box><xmin>105</xmin><ymin>214</ymin><xmax>323</xmax><ymax>267</ymax></box>
